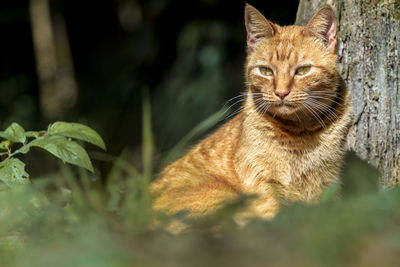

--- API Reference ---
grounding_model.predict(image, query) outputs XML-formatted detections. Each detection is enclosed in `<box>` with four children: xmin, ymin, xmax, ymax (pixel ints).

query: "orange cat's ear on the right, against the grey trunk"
<box><xmin>304</xmin><ymin>5</ymin><xmax>337</xmax><ymax>53</ymax></box>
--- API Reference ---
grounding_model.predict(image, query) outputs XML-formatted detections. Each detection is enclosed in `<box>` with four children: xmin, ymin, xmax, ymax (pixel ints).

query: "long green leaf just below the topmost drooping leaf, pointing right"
<box><xmin>27</xmin><ymin>136</ymin><xmax>94</xmax><ymax>172</ymax></box>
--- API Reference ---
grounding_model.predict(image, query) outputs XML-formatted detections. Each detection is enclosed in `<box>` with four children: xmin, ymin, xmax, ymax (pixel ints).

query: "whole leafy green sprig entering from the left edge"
<box><xmin>0</xmin><ymin>122</ymin><xmax>106</xmax><ymax>188</ymax></box>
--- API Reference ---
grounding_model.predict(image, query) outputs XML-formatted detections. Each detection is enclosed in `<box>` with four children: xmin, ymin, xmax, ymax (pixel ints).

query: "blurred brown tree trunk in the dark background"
<box><xmin>29</xmin><ymin>0</ymin><xmax>78</xmax><ymax>120</ymax></box>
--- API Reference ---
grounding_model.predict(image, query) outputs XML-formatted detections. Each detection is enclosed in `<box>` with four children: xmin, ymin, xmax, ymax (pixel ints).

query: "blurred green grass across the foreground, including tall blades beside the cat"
<box><xmin>0</xmin><ymin>97</ymin><xmax>400</xmax><ymax>267</ymax></box>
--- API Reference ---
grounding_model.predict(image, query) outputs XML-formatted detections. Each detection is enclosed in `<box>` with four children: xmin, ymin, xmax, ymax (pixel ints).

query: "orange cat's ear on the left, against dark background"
<box><xmin>244</xmin><ymin>4</ymin><xmax>277</xmax><ymax>52</ymax></box>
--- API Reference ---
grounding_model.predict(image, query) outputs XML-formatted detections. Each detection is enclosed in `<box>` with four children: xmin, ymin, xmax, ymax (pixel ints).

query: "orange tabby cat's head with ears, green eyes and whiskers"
<box><xmin>245</xmin><ymin>5</ymin><xmax>338</xmax><ymax>125</ymax></box>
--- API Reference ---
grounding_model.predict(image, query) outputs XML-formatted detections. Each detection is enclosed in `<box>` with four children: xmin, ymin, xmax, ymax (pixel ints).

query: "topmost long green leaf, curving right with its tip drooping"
<box><xmin>49</xmin><ymin>121</ymin><xmax>106</xmax><ymax>150</ymax></box>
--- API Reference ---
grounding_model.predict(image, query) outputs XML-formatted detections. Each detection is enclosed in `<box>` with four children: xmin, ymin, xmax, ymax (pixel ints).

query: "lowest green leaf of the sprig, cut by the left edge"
<box><xmin>0</xmin><ymin>158</ymin><xmax>29</xmax><ymax>187</ymax></box>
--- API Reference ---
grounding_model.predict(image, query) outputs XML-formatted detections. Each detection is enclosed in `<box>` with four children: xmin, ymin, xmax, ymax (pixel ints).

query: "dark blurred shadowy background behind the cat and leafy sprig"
<box><xmin>0</xmin><ymin>0</ymin><xmax>298</xmax><ymax>175</ymax></box>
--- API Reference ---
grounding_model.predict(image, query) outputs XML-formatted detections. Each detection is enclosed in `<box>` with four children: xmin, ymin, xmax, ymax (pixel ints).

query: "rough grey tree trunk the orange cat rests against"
<box><xmin>296</xmin><ymin>0</ymin><xmax>400</xmax><ymax>187</ymax></box>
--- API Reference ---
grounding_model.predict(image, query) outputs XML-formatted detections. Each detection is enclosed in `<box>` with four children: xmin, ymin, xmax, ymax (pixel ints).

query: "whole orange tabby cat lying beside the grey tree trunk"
<box><xmin>150</xmin><ymin>5</ymin><xmax>351</xmax><ymax>226</ymax></box>
